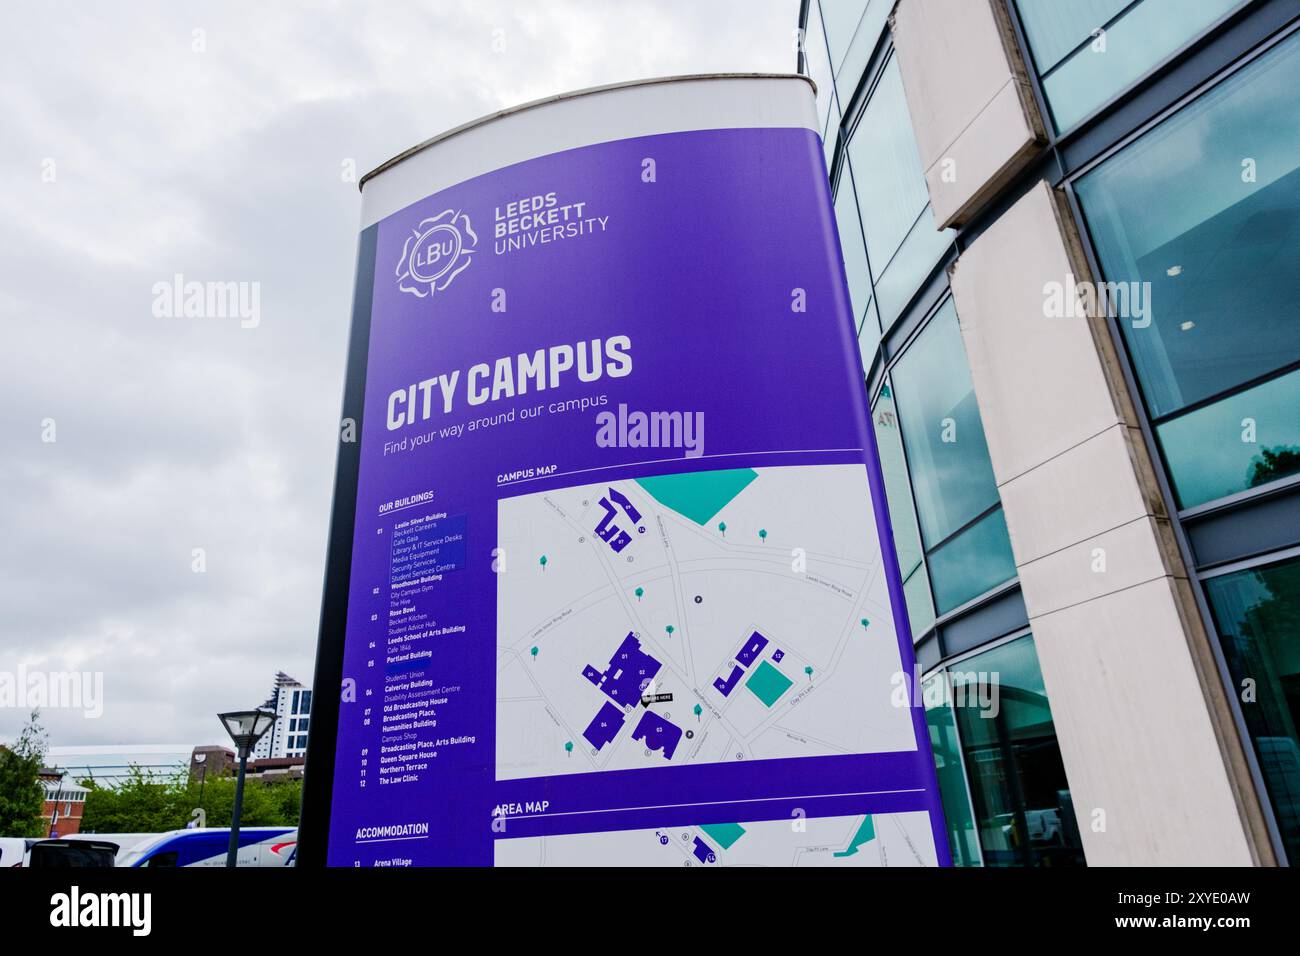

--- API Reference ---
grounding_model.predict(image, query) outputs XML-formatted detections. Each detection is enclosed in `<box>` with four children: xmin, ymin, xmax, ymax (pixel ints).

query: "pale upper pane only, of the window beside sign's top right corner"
<box><xmin>849</xmin><ymin>57</ymin><xmax>933</xmax><ymax>269</ymax></box>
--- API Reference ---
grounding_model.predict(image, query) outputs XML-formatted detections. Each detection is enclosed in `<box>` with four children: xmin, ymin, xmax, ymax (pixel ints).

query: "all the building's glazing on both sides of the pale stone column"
<box><xmin>802</xmin><ymin>0</ymin><xmax>1300</xmax><ymax>865</ymax></box>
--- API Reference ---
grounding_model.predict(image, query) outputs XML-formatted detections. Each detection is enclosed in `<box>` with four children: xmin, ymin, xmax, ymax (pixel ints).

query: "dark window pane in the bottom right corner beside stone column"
<box><xmin>1205</xmin><ymin>561</ymin><xmax>1300</xmax><ymax>866</ymax></box>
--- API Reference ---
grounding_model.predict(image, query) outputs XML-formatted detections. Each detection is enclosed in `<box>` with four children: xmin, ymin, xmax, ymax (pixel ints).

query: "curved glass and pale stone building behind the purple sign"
<box><xmin>798</xmin><ymin>0</ymin><xmax>1300</xmax><ymax>866</ymax></box>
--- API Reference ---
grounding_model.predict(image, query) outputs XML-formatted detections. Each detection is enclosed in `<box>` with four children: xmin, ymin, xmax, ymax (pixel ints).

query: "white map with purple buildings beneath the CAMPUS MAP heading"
<box><xmin>497</xmin><ymin>464</ymin><xmax>915</xmax><ymax>785</ymax></box>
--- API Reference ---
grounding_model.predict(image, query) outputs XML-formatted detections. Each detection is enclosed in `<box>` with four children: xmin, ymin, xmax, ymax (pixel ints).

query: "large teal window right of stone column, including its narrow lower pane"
<box><xmin>1075</xmin><ymin>33</ymin><xmax>1300</xmax><ymax>507</ymax></box>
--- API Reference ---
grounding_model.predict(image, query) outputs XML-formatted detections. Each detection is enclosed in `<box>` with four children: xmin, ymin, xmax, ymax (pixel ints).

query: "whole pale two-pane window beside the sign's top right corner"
<box><xmin>848</xmin><ymin>57</ymin><xmax>952</xmax><ymax>328</ymax></box>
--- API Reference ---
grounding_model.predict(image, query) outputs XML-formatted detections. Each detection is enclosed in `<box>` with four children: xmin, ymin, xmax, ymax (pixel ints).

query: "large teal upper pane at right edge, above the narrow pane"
<box><xmin>1078</xmin><ymin>38</ymin><xmax>1300</xmax><ymax>416</ymax></box>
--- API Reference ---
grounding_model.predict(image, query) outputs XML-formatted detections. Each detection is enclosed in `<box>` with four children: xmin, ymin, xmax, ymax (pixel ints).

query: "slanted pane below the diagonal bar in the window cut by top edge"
<box><xmin>1043</xmin><ymin>0</ymin><xmax>1248</xmax><ymax>131</ymax></box>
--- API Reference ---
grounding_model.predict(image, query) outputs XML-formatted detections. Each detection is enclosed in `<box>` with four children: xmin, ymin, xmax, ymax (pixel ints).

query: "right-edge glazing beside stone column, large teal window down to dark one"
<box><xmin>1066</xmin><ymin>18</ymin><xmax>1300</xmax><ymax>862</ymax></box>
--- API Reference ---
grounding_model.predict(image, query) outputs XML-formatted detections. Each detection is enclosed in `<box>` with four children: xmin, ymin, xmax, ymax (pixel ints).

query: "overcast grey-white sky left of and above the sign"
<box><xmin>0</xmin><ymin>0</ymin><xmax>798</xmax><ymax>747</ymax></box>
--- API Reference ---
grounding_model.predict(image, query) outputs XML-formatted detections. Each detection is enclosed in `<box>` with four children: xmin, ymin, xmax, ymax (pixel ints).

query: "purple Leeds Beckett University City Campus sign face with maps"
<box><xmin>308</xmin><ymin>82</ymin><xmax>948</xmax><ymax>866</ymax></box>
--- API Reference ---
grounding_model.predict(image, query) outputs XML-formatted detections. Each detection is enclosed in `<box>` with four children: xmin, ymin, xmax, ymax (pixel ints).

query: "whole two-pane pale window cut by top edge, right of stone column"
<box><xmin>1017</xmin><ymin>0</ymin><xmax>1249</xmax><ymax>131</ymax></box>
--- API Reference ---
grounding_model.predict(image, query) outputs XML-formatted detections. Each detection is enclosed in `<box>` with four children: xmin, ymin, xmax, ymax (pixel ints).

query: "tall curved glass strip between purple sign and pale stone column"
<box><xmin>805</xmin><ymin>0</ymin><xmax>1083</xmax><ymax>866</ymax></box>
